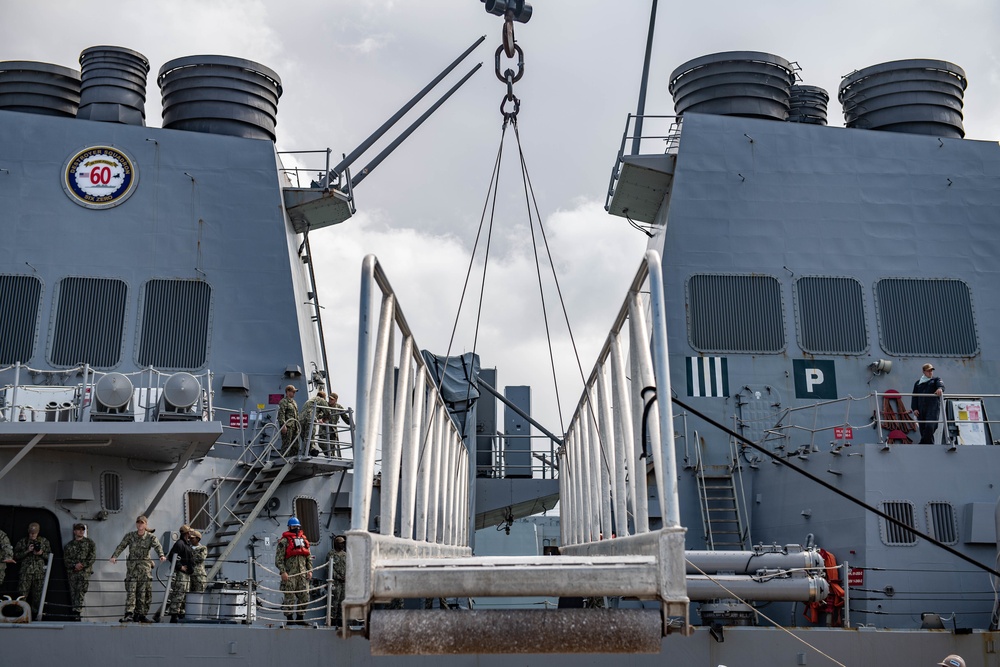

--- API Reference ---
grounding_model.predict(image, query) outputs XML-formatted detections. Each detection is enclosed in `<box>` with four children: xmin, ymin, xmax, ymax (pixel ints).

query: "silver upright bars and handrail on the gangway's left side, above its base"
<box><xmin>351</xmin><ymin>255</ymin><xmax>469</xmax><ymax>546</ymax></box>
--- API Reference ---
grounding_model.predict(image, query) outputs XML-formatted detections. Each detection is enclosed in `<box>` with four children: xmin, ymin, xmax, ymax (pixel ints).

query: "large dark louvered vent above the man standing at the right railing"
<box><xmin>875</xmin><ymin>278</ymin><xmax>979</xmax><ymax>357</ymax></box>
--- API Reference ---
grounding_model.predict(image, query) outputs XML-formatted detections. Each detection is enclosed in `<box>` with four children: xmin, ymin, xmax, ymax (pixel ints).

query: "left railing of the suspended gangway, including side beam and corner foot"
<box><xmin>343</xmin><ymin>255</ymin><xmax>472</xmax><ymax>635</ymax></box>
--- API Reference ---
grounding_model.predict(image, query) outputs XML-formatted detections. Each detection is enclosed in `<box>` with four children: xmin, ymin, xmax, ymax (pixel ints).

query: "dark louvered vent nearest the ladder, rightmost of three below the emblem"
<box><xmin>138</xmin><ymin>280</ymin><xmax>212</xmax><ymax>370</ymax></box>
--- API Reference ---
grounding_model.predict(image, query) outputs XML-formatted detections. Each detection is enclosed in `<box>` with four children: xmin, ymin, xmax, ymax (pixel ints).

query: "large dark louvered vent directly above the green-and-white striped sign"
<box><xmin>688</xmin><ymin>274</ymin><xmax>785</xmax><ymax>353</ymax></box>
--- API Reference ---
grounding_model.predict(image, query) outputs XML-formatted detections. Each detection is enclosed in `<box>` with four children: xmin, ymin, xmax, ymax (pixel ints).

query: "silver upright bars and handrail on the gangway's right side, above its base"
<box><xmin>560</xmin><ymin>250</ymin><xmax>680</xmax><ymax>545</ymax></box>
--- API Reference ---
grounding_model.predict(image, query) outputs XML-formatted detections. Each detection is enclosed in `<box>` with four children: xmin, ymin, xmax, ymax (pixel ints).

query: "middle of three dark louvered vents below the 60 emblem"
<box><xmin>50</xmin><ymin>278</ymin><xmax>128</xmax><ymax>368</ymax></box>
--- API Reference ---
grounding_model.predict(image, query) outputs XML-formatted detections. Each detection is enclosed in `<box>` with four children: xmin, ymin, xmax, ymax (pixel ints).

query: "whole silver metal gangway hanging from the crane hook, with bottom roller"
<box><xmin>342</xmin><ymin>251</ymin><xmax>688</xmax><ymax>655</ymax></box>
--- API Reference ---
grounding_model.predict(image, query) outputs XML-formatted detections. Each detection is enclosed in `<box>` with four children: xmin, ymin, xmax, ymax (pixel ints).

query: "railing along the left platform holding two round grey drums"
<box><xmin>0</xmin><ymin>363</ymin><xmax>213</xmax><ymax>422</ymax></box>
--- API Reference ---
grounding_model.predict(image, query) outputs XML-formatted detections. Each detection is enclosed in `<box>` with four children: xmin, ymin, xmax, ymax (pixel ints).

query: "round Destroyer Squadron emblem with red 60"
<box><xmin>63</xmin><ymin>146</ymin><xmax>139</xmax><ymax>208</ymax></box>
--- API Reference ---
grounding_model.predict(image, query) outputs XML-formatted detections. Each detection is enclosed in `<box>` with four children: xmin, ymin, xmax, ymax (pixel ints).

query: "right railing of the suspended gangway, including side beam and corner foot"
<box><xmin>560</xmin><ymin>250</ymin><xmax>688</xmax><ymax>634</ymax></box>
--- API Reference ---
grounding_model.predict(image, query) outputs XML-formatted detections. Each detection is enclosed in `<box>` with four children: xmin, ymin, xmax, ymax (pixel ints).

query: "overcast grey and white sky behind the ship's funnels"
<box><xmin>0</xmin><ymin>0</ymin><xmax>1000</xmax><ymax>438</ymax></box>
